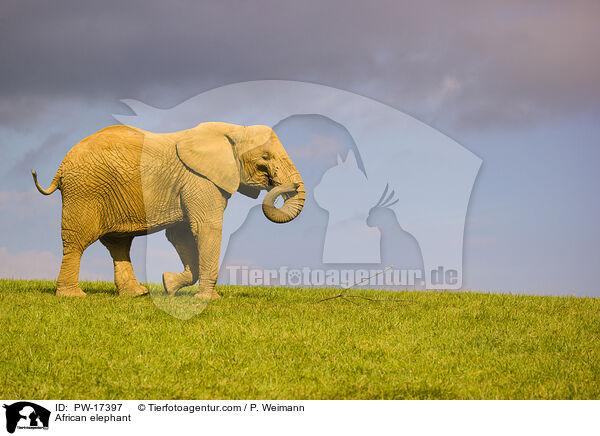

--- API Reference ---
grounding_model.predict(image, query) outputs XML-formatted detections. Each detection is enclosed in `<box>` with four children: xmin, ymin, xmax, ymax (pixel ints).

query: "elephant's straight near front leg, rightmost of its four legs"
<box><xmin>192</xmin><ymin>221</ymin><xmax>223</xmax><ymax>298</ymax></box>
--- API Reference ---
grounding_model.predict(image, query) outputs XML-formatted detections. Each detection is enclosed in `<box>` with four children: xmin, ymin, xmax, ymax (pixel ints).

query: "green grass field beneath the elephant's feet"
<box><xmin>0</xmin><ymin>280</ymin><xmax>600</xmax><ymax>399</ymax></box>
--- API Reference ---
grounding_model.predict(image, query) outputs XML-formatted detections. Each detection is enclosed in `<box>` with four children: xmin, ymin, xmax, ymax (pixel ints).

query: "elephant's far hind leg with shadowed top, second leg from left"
<box><xmin>100</xmin><ymin>236</ymin><xmax>148</xmax><ymax>297</ymax></box>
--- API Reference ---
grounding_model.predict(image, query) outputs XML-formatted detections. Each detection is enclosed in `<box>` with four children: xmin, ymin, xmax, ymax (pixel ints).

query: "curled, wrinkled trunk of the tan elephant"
<box><xmin>263</xmin><ymin>171</ymin><xmax>306</xmax><ymax>223</ymax></box>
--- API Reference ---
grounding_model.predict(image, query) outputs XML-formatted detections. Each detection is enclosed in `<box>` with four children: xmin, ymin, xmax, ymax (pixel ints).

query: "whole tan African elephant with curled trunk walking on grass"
<box><xmin>32</xmin><ymin>122</ymin><xmax>306</xmax><ymax>298</ymax></box>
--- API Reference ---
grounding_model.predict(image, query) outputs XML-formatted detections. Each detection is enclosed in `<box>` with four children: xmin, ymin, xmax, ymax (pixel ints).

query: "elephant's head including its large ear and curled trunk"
<box><xmin>177</xmin><ymin>123</ymin><xmax>306</xmax><ymax>223</ymax></box>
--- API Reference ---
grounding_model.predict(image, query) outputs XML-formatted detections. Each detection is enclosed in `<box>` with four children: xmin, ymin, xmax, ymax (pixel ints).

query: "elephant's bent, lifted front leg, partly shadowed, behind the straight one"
<box><xmin>163</xmin><ymin>223</ymin><xmax>198</xmax><ymax>294</ymax></box>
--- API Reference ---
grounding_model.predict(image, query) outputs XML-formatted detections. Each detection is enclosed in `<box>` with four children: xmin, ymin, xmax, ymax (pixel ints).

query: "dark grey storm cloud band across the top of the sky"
<box><xmin>0</xmin><ymin>1</ymin><xmax>600</xmax><ymax>126</ymax></box>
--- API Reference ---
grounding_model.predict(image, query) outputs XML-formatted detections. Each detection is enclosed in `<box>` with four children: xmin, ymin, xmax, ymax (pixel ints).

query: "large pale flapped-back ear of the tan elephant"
<box><xmin>176</xmin><ymin>123</ymin><xmax>240</xmax><ymax>194</ymax></box>
